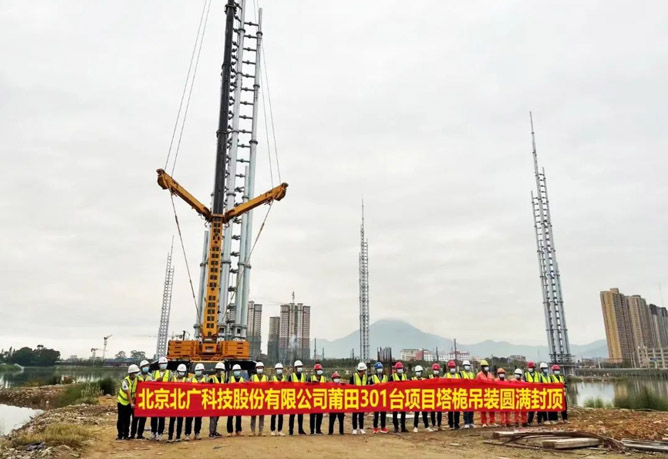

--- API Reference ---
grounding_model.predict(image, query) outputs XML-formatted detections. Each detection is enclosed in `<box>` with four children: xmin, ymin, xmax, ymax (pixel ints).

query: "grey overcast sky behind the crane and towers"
<box><xmin>0</xmin><ymin>0</ymin><xmax>668</xmax><ymax>355</ymax></box>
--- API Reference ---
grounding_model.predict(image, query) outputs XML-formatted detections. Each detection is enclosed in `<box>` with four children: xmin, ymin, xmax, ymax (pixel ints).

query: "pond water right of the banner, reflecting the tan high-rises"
<box><xmin>568</xmin><ymin>377</ymin><xmax>668</xmax><ymax>406</ymax></box>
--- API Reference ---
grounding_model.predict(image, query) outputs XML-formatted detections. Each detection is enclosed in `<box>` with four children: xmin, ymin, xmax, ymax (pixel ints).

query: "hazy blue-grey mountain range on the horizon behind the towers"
<box><xmin>311</xmin><ymin>319</ymin><xmax>608</xmax><ymax>360</ymax></box>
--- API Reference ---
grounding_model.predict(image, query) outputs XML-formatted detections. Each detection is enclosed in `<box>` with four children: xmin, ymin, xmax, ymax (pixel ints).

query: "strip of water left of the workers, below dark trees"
<box><xmin>0</xmin><ymin>367</ymin><xmax>127</xmax><ymax>388</ymax></box>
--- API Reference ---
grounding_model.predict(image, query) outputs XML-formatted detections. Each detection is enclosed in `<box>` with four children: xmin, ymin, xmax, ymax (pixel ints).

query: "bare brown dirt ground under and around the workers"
<box><xmin>0</xmin><ymin>397</ymin><xmax>668</xmax><ymax>459</ymax></box>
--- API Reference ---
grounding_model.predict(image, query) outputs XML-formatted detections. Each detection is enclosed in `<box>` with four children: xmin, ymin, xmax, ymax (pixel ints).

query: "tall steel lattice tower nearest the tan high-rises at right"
<box><xmin>529</xmin><ymin>112</ymin><xmax>571</xmax><ymax>364</ymax></box>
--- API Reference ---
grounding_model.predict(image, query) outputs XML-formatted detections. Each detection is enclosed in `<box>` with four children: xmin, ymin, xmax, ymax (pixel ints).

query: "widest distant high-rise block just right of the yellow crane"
<box><xmin>278</xmin><ymin>294</ymin><xmax>311</xmax><ymax>363</ymax></box>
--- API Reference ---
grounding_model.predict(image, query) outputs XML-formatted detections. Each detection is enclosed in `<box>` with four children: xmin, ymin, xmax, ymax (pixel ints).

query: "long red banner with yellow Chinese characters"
<box><xmin>135</xmin><ymin>378</ymin><xmax>565</xmax><ymax>417</ymax></box>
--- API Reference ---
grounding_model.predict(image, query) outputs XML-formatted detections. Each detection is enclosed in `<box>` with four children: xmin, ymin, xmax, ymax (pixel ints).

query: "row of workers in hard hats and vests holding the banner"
<box><xmin>116</xmin><ymin>357</ymin><xmax>568</xmax><ymax>442</ymax></box>
